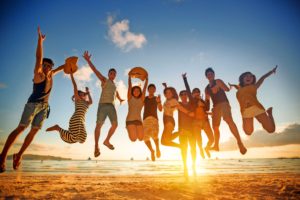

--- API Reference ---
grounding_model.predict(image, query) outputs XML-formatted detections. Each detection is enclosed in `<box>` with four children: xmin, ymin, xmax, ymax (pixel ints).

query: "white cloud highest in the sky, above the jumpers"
<box><xmin>107</xmin><ymin>15</ymin><xmax>147</xmax><ymax>52</ymax></box>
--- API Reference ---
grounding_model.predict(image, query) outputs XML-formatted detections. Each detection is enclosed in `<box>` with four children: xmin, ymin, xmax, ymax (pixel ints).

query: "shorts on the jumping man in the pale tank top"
<box><xmin>96</xmin><ymin>103</ymin><xmax>118</xmax><ymax>125</ymax></box>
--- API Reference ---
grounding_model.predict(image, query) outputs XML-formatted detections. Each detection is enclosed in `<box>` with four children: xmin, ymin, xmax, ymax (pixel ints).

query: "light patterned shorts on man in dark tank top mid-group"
<box><xmin>143</xmin><ymin>116</ymin><xmax>159</xmax><ymax>141</ymax></box>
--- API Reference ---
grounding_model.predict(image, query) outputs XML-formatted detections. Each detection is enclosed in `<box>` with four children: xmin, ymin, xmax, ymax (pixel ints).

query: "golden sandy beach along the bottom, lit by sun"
<box><xmin>0</xmin><ymin>173</ymin><xmax>300</xmax><ymax>200</ymax></box>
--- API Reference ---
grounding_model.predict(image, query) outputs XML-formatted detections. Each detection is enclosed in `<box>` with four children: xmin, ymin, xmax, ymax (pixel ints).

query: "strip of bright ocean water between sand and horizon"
<box><xmin>2</xmin><ymin>158</ymin><xmax>300</xmax><ymax>176</ymax></box>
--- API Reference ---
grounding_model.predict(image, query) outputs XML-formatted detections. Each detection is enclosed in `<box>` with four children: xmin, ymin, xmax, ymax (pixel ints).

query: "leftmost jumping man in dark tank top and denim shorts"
<box><xmin>0</xmin><ymin>27</ymin><xmax>64</xmax><ymax>172</ymax></box>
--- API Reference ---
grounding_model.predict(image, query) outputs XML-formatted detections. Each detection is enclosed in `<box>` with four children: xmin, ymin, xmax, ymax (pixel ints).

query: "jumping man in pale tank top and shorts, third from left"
<box><xmin>83</xmin><ymin>51</ymin><xmax>124</xmax><ymax>157</ymax></box>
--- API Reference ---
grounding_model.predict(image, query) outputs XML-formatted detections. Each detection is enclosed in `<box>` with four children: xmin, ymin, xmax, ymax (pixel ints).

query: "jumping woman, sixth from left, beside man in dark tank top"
<box><xmin>161</xmin><ymin>83</ymin><xmax>193</xmax><ymax>148</ymax></box>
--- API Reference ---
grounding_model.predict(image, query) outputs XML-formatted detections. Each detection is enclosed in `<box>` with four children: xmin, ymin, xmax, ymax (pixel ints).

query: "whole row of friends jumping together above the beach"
<box><xmin>0</xmin><ymin>28</ymin><xmax>277</xmax><ymax>175</ymax></box>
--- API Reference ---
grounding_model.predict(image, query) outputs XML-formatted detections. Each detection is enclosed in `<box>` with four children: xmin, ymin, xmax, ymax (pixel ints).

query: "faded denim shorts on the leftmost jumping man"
<box><xmin>19</xmin><ymin>102</ymin><xmax>48</xmax><ymax>129</ymax></box>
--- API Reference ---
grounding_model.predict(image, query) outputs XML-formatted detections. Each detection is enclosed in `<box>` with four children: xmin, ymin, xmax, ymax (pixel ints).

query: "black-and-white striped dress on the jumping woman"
<box><xmin>59</xmin><ymin>100</ymin><xmax>89</xmax><ymax>144</ymax></box>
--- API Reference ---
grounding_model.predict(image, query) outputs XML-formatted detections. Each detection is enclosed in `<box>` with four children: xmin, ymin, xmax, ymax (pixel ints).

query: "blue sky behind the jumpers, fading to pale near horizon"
<box><xmin>0</xmin><ymin>0</ymin><xmax>300</xmax><ymax>159</ymax></box>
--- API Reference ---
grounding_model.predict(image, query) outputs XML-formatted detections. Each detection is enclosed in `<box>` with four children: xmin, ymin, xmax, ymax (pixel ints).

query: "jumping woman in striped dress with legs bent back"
<box><xmin>46</xmin><ymin>70</ymin><xmax>92</xmax><ymax>144</ymax></box>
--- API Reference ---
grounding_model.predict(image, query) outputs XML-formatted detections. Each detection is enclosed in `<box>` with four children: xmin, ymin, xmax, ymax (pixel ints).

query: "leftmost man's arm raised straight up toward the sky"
<box><xmin>34</xmin><ymin>27</ymin><xmax>46</xmax><ymax>75</ymax></box>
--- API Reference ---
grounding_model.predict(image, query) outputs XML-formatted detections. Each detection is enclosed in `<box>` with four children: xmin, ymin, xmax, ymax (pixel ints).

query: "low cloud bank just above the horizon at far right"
<box><xmin>220</xmin><ymin>123</ymin><xmax>300</xmax><ymax>151</ymax></box>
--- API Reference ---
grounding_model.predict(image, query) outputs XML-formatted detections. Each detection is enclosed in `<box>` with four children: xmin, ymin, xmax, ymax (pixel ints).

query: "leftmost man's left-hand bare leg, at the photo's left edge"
<box><xmin>0</xmin><ymin>125</ymin><xmax>26</xmax><ymax>170</ymax></box>
